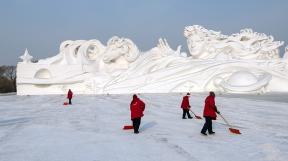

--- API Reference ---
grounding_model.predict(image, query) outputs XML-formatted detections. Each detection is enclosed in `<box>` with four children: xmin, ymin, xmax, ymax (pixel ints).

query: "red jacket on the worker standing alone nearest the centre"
<box><xmin>130</xmin><ymin>95</ymin><xmax>145</xmax><ymax>120</ymax></box>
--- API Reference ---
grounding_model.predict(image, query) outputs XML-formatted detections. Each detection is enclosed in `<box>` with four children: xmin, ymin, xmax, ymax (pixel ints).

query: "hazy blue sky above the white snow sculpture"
<box><xmin>0</xmin><ymin>0</ymin><xmax>288</xmax><ymax>65</ymax></box>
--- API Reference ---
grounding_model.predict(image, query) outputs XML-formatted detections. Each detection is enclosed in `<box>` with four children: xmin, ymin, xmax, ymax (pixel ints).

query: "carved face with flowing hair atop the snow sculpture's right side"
<box><xmin>184</xmin><ymin>25</ymin><xmax>283</xmax><ymax>59</ymax></box>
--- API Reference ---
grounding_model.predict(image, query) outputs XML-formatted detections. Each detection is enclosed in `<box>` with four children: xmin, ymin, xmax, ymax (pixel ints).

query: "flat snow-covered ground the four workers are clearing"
<box><xmin>0</xmin><ymin>94</ymin><xmax>288</xmax><ymax>161</ymax></box>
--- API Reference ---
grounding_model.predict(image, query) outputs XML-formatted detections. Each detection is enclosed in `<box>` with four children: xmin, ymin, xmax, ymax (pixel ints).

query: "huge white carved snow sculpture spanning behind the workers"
<box><xmin>17</xmin><ymin>25</ymin><xmax>288</xmax><ymax>95</ymax></box>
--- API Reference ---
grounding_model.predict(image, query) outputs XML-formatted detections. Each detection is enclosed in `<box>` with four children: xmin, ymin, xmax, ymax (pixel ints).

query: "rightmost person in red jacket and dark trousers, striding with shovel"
<box><xmin>201</xmin><ymin>92</ymin><xmax>220</xmax><ymax>135</ymax></box>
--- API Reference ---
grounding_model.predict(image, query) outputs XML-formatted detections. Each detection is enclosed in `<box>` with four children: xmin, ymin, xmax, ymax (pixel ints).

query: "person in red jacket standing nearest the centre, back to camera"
<box><xmin>130</xmin><ymin>94</ymin><xmax>145</xmax><ymax>134</ymax></box>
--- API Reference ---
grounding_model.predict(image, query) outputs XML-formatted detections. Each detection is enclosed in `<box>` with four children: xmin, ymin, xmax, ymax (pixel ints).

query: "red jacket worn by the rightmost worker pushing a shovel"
<box><xmin>203</xmin><ymin>96</ymin><xmax>217</xmax><ymax>119</ymax></box>
